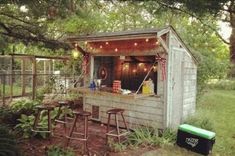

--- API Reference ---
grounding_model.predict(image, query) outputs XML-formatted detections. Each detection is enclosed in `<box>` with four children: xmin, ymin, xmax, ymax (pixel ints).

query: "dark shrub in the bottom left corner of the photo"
<box><xmin>0</xmin><ymin>125</ymin><xmax>21</xmax><ymax>156</ymax></box>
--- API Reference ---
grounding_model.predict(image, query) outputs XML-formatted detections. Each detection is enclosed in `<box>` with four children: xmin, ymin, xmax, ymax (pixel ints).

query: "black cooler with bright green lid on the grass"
<box><xmin>176</xmin><ymin>124</ymin><xmax>215</xmax><ymax>155</ymax></box>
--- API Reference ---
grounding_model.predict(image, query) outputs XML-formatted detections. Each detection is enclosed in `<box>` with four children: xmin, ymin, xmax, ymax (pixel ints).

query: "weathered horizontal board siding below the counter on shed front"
<box><xmin>84</xmin><ymin>94</ymin><xmax>163</xmax><ymax>128</ymax></box>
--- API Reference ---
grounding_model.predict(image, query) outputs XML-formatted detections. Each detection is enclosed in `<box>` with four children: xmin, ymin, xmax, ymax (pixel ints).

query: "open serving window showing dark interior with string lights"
<box><xmin>93</xmin><ymin>56</ymin><xmax>158</xmax><ymax>94</ymax></box>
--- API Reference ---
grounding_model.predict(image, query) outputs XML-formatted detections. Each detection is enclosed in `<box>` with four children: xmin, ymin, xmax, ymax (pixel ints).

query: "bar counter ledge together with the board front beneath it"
<box><xmin>70</xmin><ymin>87</ymin><xmax>164</xmax><ymax>129</ymax></box>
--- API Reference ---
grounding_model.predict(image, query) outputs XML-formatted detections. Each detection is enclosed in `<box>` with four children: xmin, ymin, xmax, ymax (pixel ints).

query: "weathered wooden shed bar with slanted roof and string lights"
<box><xmin>68</xmin><ymin>26</ymin><xmax>197</xmax><ymax>129</ymax></box>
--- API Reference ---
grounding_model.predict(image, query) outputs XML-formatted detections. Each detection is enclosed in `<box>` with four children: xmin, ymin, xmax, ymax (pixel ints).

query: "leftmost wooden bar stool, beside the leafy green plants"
<box><xmin>32</xmin><ymin>105</ymin><xmax>54</xmax><ymax>134</ymax></box>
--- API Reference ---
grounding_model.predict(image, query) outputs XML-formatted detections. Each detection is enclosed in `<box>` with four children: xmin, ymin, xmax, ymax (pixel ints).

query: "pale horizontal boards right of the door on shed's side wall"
<box><xmin>183</xmin><ymin>52</ymin><xmax>197</xmax><ymax>120</ymax></box>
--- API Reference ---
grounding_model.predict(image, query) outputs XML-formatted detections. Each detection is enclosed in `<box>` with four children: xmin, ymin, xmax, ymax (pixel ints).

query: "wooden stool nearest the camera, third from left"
<box><xmin>65</xmin><ymin>111</ymin><xmax>91</xmax><ymax>153</ymax></box>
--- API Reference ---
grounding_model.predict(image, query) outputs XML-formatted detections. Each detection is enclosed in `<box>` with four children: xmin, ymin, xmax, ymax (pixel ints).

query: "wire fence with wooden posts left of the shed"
<box><xmin>0</xmin><ymin>71</ymin><xmax>76</xmax><ymax>105</ymax></box>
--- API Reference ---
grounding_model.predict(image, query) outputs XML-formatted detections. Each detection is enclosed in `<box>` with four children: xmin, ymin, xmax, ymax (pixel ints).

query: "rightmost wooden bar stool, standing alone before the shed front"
<box><xmin>106</xmin><ymin>108</ymin><xmax>129</xmax><ymax>143</ymax></box>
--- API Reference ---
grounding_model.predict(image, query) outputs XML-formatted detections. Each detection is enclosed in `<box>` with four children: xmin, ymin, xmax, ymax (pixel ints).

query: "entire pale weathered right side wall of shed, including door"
<box><xmin>167</xmin><ymin>33</ymin><xmax>197</xmax><ymax>128</ymax></box>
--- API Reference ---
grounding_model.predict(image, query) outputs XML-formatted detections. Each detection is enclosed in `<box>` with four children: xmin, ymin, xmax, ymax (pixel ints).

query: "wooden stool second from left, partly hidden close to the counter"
<box><xmin>55</xmin><ymin>101</ymin><xmax>70</xmax><ymax>134</ymax></box>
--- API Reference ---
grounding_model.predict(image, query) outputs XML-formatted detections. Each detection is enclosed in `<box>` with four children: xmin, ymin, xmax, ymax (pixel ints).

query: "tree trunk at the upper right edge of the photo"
<box><xmin>230</xmin><ymin>13</ymin><xmax>235</xmax><ymax>77</ymax></box>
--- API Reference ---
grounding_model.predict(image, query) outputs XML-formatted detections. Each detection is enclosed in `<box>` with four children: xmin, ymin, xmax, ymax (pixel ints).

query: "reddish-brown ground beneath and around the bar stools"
<box><xmin>20</xmin><ymin>121</ymin><xmax>154</xmax><ymax>156</ymax></box>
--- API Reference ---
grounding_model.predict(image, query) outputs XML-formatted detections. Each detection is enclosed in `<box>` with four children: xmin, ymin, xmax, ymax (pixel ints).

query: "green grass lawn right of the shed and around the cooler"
<box><xmin>143</xmin><ymin>90</ymin><xmax>235</xmax><ymax>156</ymax></box>
